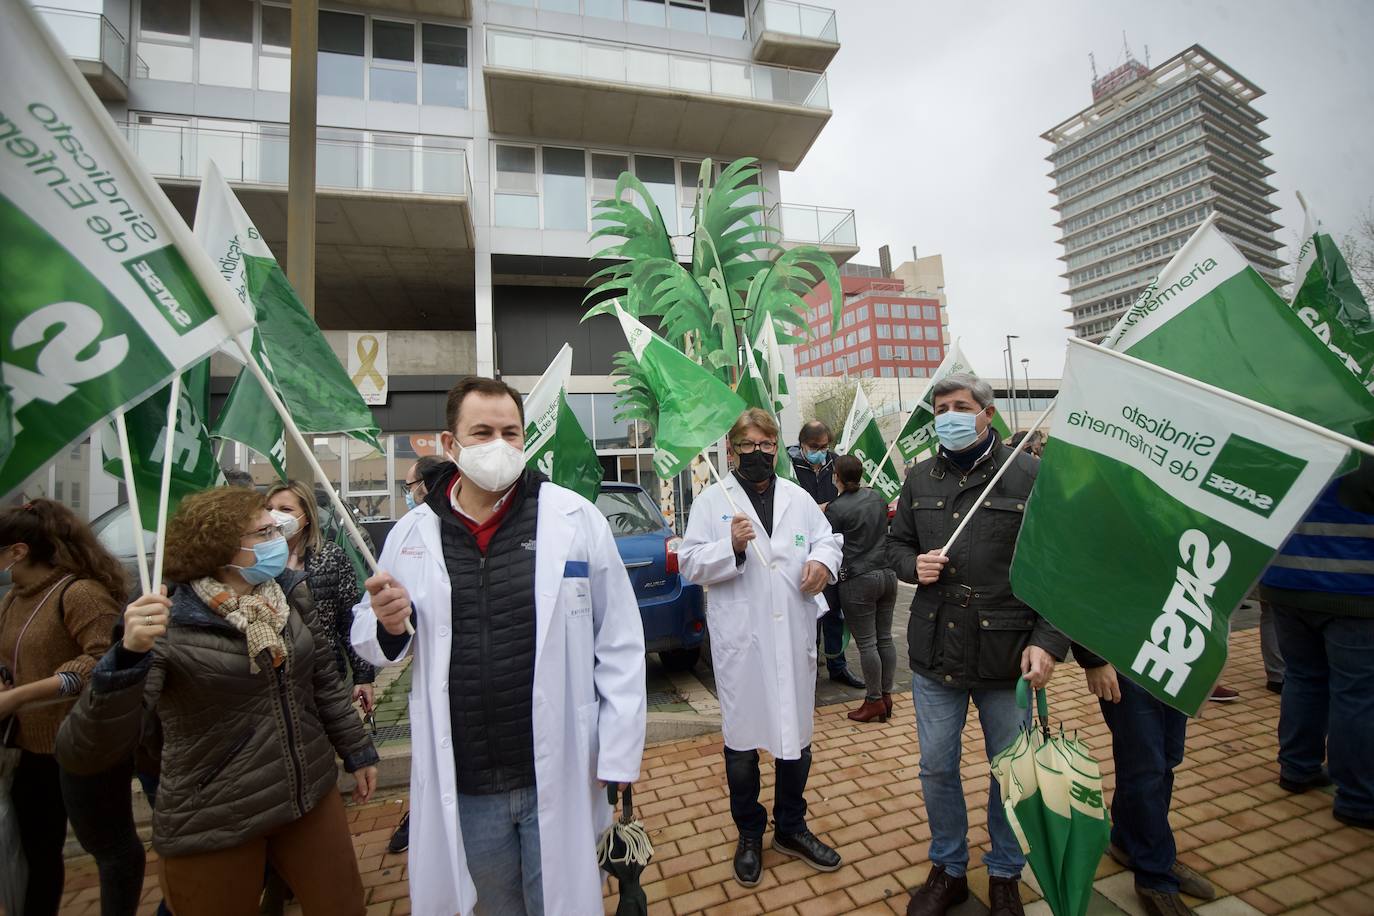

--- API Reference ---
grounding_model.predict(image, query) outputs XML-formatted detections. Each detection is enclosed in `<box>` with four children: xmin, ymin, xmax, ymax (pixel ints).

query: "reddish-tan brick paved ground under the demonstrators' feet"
<box><xmin>63</xmin><ymin>629</ymin><xmax>1374</xmax><ymax>916</ymax></box>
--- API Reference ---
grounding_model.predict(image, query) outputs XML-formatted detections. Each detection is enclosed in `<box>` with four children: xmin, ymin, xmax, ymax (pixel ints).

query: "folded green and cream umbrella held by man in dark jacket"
<box><xmin>992</xmin><ymin>680</ymin><xmax>1112</xmax><ymax>916</ymax></box>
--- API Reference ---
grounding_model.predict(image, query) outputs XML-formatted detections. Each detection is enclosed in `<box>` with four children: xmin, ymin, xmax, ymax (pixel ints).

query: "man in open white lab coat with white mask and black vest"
<box><xmin>352</xmin><ymin>378</ymin><xmax>644</xmax><ymax>916</ymax></box>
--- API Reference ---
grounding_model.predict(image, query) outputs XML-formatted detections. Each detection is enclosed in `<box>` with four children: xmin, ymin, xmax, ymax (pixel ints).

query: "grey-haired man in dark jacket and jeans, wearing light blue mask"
<box><xmin>888</xmin><ymin>372</ymin><xmax>1069</xmax><ymax>916</ymax></box>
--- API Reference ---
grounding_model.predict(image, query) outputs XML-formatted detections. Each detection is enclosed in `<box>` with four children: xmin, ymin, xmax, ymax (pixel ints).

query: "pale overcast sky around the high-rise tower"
<box><xmin>782</xmin><ymin>0</ymin><xmax>1374</xmax><ymax>378</ymax></box>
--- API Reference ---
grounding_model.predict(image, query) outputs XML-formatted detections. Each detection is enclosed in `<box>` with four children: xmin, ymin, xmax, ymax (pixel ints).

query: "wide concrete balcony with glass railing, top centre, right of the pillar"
<box><xmin>482</xmin><ymin>27</ymin><xmax>830</xmax><ymax>170</ymax></box>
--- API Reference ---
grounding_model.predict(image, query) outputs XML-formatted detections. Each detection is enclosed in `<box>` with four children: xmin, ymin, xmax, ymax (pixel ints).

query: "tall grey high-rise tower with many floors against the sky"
<box><xmin>1040</xmin><ymin>45</ymin><xmax>1283</xmax><ymax>342</ymax></box>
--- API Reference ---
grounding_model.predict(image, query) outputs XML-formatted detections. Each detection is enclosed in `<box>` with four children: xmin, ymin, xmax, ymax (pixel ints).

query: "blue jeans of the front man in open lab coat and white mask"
<box><xmin>458</xmin><ymin>786</ymin><xmax>544</xmax><ymax>916</ymax></box>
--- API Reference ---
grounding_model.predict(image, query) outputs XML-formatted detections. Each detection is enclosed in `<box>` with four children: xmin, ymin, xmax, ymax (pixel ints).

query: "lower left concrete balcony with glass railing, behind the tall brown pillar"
<box><xmin>121</xmin><ymin>124</ymin><xmax>475</xmax><ymax>330</ymax></box>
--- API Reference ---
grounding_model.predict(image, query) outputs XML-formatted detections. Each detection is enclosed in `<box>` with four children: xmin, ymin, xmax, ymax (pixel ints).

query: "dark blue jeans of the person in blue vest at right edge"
<box><xmin>1274</xmin><ymin>604</ymin><xmax>1374</xmax><ymax>817</ymax></box>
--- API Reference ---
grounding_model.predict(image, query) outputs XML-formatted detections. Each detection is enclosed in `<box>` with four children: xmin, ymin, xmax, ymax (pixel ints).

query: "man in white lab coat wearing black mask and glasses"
<box><xmin>677</xmin><ymin>408</ymin><xmax>841</xmax><ymax>887</ymax></box>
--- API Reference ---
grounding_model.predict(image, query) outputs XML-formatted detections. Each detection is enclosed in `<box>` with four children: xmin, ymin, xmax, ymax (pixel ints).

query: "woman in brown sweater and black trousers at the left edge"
<box><xmin>0</xmin><ymin>500</ymin><xmax>144</xmax><ymax>916</ymax></box>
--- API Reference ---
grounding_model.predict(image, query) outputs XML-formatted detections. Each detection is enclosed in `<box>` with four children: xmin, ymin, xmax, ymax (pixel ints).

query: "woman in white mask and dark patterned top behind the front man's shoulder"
<box><xmin>267</xmin><ymin>481</ymin><xmax>376</xmax><ymax>711</ymax></box>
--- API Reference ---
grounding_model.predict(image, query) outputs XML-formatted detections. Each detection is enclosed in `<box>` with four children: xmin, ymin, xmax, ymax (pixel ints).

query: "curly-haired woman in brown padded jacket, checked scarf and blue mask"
<box><xmin>58</xmin><ymin>488</ymin><xmax>378</xmax><ymax>916</ymax></box>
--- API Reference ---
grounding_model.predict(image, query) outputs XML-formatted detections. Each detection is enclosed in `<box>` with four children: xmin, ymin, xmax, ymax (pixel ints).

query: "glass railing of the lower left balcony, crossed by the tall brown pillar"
<box><xmin>121</xmin><ymin>124</ymin><xmax>473</xmax><ymax>198</ymax></box>
